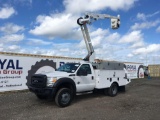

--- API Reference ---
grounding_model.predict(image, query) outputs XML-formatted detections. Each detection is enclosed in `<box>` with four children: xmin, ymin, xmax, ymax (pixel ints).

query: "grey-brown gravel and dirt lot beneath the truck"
<box><xmin>0</xmin><ymin>78</ymin><xmax>160</xmax><ymax>120</ymax></box>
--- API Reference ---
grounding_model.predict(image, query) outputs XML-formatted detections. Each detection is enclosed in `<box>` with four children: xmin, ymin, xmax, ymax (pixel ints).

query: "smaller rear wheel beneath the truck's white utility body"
<box><xmin>108</xmin><ymin>83</ymin><xmax>118</xmax><ymax>97</ymax></box>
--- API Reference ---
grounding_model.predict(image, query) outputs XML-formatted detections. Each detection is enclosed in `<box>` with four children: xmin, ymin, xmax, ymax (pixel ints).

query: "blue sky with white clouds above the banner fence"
<box><xmin>0</xmin><ymin>0</ymin><xmax>160</xmax><ymax>64</ymax></box>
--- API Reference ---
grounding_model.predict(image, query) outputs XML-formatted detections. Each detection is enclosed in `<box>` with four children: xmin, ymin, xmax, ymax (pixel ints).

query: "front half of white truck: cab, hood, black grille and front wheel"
<box><xmin>27</xmin><ymin>63</ymin><xmax>96</xmax><ymax>107</ymax></box>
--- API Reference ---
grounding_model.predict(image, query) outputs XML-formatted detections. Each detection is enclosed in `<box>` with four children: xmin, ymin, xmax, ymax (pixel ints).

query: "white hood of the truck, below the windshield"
<box><xmin>45</xmin><ymin>71</ymin><xmax>72</xmax><ymax>77</ymax></box>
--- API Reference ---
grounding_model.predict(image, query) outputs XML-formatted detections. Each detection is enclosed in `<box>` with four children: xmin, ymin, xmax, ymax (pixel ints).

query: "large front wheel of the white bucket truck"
<box><xmin>55</xmin><ymin>88</ymin><xmax>73</xmax><ymax>107</ymax></box>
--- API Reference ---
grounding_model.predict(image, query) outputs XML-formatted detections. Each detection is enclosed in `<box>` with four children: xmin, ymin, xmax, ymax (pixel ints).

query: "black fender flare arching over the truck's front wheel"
<box><xmin>53</xmin><ymin>77</ymin><xmax>76</xmax><ymax>95</ymax></box>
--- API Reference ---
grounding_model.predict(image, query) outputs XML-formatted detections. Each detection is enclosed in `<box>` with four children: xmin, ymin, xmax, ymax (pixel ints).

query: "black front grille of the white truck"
<box><xmin>31</xmin><ymin>74</ymin><xmax>47</xmax><ymax>88</ymax></box>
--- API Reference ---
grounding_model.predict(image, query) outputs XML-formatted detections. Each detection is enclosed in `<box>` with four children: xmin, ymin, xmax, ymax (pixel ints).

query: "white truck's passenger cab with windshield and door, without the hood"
<box><xmin>53</xmin><ymin>63</ymin><xmax>95</xmax><ymax>92</ymax></box>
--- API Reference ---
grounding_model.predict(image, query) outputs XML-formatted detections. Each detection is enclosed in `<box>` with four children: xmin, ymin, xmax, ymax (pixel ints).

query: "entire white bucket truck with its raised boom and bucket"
<box><xmin>27</xmin><ymin>14</ymin><xmax>130</xmax><ymax>107</ymax></box>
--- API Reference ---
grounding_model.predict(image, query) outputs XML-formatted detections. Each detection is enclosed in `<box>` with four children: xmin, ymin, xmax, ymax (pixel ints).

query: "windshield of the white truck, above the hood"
<box><xmin>57</xmin><ymin>63</ymin><xmax>80</xmax><ymax>73</ymax></box>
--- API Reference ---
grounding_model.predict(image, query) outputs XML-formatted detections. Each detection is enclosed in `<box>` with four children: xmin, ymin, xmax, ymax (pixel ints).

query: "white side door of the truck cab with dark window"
<box><xmin>75</xmin><ymin>64</ymin><xmax>95</xmax><ymax>92</ymax></box>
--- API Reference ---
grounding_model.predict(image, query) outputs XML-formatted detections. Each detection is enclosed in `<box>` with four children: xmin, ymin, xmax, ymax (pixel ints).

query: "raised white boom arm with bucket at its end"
<box><xmin>77</xmin><ymin>13</ymin><xmax>120</xmax><ymax>62</ymax></box>
